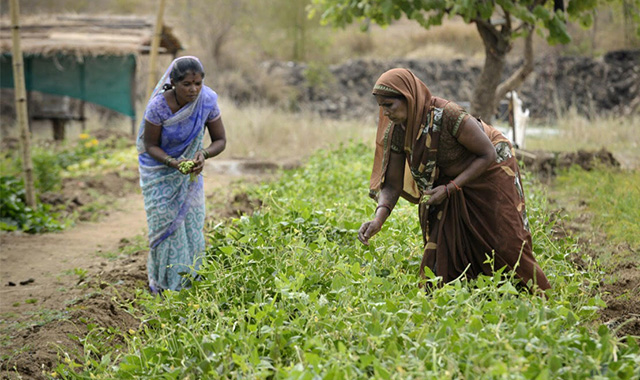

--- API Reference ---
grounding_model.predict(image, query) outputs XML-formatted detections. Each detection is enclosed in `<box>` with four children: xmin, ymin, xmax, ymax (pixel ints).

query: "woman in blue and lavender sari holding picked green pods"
<box><xmin>136</xmin><ymin>56</ymin><xmax>226</xmax><ymax>294</ymax></box>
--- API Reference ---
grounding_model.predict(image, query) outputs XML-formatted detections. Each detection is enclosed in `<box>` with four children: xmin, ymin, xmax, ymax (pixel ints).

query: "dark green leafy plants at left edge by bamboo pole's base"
<box><xmin>0</xmin><ymin>176</ymin><xmax>62</xmax><ymax>233</ymax></box>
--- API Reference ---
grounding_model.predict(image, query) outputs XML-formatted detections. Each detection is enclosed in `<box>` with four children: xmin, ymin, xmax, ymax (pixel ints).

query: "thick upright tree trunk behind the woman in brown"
<box><xmin>471</xmin><ymin>17</ymin><xmax>511</xmax><ymax>123</ymax></box>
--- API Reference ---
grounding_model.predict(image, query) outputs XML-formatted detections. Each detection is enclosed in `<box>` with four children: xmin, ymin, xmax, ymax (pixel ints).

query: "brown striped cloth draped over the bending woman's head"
<box><xmin>369</xmin><ymin>68</ymin><xmax>431</xmax><ymax>202</ymax></box>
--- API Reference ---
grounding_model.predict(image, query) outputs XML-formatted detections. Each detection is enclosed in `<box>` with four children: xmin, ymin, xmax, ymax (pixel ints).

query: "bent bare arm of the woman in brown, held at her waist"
<box><xmin>427</xmin><ymin>117</ymin><xmax>497</xmax><ymax>205</ymax></box>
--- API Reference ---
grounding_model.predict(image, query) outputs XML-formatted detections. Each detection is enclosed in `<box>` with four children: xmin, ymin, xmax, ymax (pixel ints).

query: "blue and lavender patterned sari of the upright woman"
<box><xmin>136</xmin><ymin>58</ymin><xmax>220</xmax><ymax>293</ymax></box>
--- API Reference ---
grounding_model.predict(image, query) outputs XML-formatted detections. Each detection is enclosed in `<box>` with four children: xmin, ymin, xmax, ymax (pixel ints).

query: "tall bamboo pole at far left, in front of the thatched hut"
<box><xmin>9</xmin><ymin>0</ymin><xmax>36</xmax><ymax>209</ymax></box>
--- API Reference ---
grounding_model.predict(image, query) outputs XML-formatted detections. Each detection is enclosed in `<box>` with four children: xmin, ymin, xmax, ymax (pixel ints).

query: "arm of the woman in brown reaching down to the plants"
<box><xmin>358</xmin><ymin>152</ymin><xmax>406</xmax><ymax>245</ymax></box>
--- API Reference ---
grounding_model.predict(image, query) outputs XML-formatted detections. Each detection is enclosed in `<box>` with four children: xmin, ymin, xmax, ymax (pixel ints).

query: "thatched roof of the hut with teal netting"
<box><xmin>0</xmin><ymin>14</ymin><xmax>182</xmax><ymax>57</ymax></box>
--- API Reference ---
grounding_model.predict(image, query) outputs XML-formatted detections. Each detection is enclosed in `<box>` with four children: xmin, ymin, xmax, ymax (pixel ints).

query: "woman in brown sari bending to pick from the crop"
<box><xmin>358</xmin><ymin>69</ymin><xmax>551</xmax><ymax>291</ymax></box>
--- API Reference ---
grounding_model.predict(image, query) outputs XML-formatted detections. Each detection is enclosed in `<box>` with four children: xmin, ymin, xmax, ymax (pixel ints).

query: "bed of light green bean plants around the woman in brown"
<box><xmin>57</xmin><ymin>145</ymin><xmax>640</xmax><ymax>379</ymax></box>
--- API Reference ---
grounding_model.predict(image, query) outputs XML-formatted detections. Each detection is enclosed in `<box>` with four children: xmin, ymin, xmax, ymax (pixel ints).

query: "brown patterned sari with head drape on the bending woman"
<box><xmin>370</xmin><ymin>69</ymin><xmax>551</xmax><ymax>290</ymax></box>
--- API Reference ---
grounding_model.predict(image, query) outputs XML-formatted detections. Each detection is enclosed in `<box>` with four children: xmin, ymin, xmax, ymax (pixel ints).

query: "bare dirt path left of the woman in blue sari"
<box><xmin>0</xmin><ymin>194</ymin><xmax>146</xmax><ymax>314</ymax></box>
